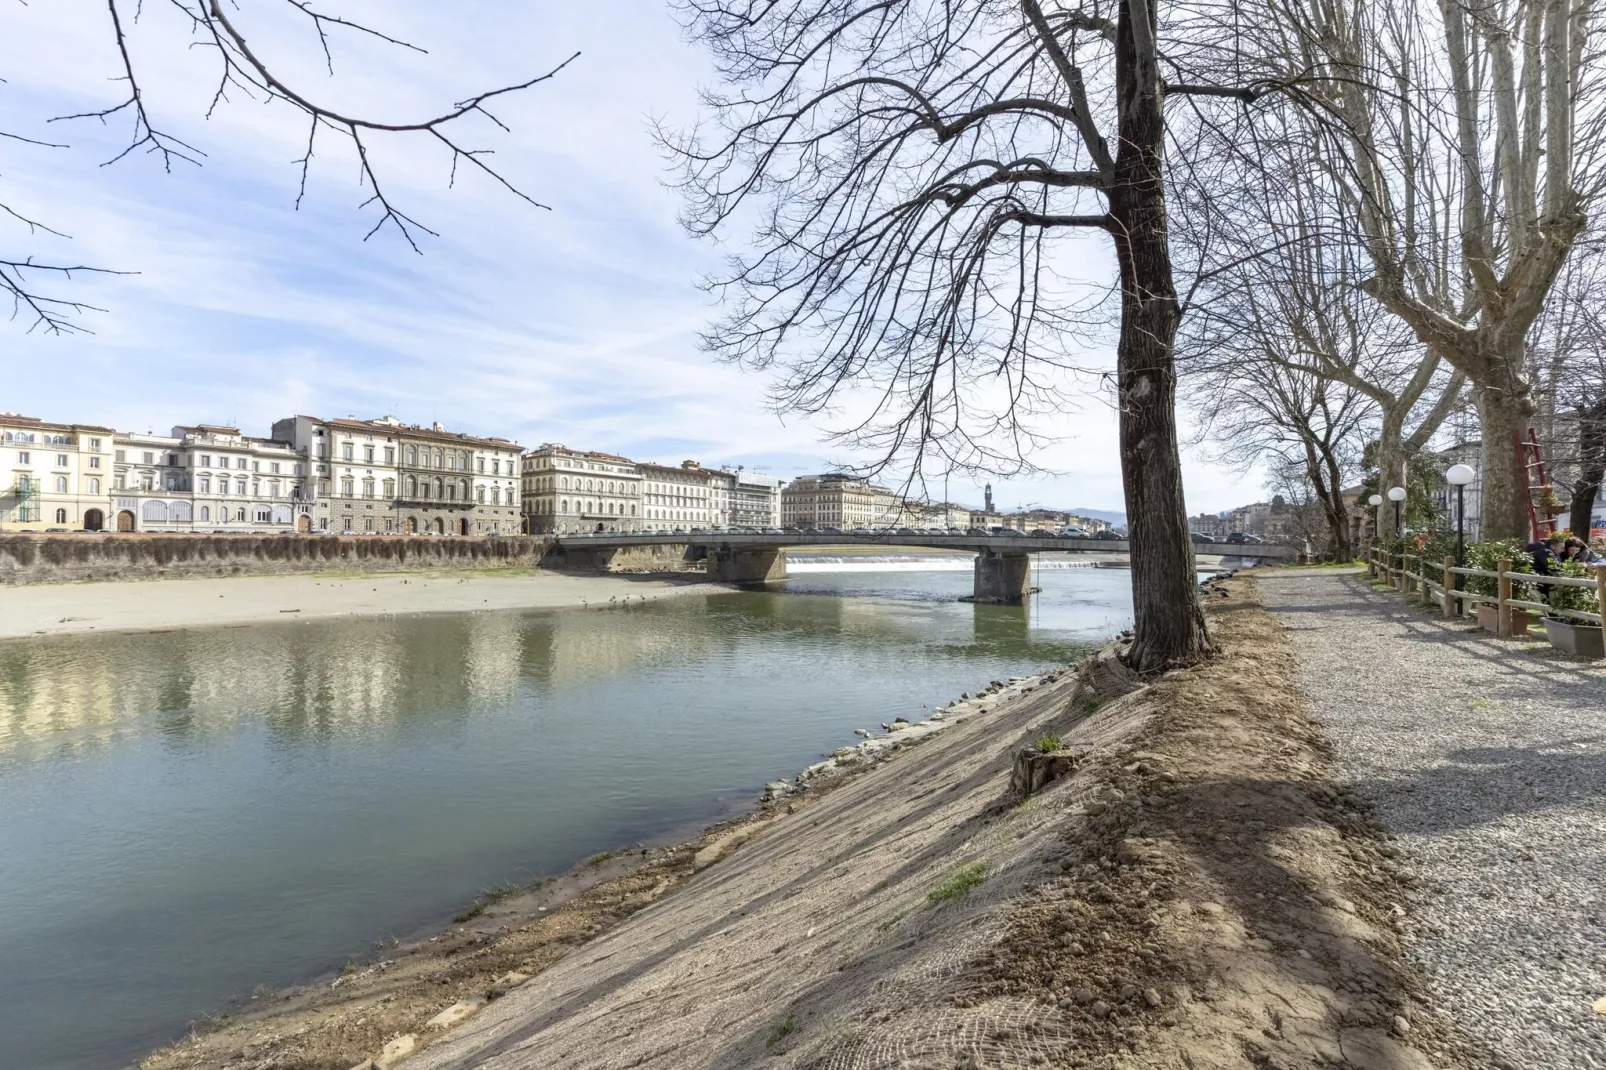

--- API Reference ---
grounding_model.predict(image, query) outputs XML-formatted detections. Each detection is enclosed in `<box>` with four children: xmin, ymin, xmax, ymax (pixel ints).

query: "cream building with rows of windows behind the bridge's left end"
<box><xmin>522</xmin><ymin>442</ymin><xmax>642</xmax><ymax>533</ymax></box>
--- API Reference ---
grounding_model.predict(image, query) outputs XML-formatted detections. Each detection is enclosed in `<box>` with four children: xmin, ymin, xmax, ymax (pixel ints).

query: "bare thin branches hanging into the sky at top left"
<box><xmin>0</xmin><ymin>0</ymin><xmax>578</xmax><ymax>333</ymax></box>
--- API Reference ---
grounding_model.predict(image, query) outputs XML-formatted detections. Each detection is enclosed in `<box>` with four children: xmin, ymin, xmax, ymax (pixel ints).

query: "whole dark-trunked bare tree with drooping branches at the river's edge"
<box><xmin>670</xmin><ymin>0</ymin><xmax>1253</xmax><ymax>672</ymax></box>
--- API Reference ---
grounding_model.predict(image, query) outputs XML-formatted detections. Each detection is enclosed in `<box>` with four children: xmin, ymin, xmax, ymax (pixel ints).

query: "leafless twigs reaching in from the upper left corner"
<box><xmin>0</xmin><ymin>0</ymin><xmax>578</xmax><ymax>334</ymax></box>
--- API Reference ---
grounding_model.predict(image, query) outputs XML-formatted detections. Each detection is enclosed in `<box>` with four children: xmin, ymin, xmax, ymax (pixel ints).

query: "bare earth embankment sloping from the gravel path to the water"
<box><xmin>143</xmin><ymin>582</ymin><xmax>1484</xmax><ymax>1070</ymax></box>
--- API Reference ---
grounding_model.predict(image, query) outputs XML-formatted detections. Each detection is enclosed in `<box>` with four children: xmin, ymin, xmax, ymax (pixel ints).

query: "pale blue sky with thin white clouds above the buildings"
<box><xmin>0</xmin><ymin>0</ymin><xmax>1264</xmax><ymax>513</ymax></box>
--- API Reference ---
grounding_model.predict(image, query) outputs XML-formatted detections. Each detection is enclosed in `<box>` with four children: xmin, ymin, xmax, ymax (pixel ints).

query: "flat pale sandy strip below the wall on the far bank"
<box><xmin>0</xmin><ymin>569</ymin><xmax>718</xmax><ymax>639</ymax></box>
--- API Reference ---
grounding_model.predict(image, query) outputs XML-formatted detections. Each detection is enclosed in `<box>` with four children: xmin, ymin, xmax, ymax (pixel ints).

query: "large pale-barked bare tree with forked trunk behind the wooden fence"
<box><xmin>1214</xmin><ymin>0</ymin><xmax>1606</xmax><ymax>537</ymax></box>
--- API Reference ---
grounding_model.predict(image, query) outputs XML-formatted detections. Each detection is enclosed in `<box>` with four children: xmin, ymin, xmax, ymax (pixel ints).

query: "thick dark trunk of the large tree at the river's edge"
<box><xmin>1110</xmin><ymin>0</ymin><xmax>1209</xmax><ymax>673</ymax></box>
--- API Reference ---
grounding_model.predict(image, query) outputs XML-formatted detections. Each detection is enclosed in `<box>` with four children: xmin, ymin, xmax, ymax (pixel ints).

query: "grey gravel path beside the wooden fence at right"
<box><xmin>1259</xmin><ymin>570</ymin><xmax>1606</xmax><ymax>1070</ymax></box>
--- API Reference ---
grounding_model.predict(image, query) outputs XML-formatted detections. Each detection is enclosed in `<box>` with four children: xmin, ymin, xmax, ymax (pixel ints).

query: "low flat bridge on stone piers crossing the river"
<box><xmin>552</xmin><ymin>532</ymin><xmax>1299</xmax><ymax>602</ymax></box>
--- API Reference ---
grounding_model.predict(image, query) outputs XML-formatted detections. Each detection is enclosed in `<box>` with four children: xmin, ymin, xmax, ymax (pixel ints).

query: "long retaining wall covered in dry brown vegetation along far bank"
<box><xmin>0</xmin><ymin>533</ymin><xmax>551</xmax><ymax>585</ymax></box>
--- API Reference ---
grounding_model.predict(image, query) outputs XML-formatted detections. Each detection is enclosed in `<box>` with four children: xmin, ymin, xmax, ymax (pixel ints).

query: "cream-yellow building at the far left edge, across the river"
<box><xmin>0</xmin><ymin>413</ymin><xmax>112</xmax><ymax>532</ymax></box>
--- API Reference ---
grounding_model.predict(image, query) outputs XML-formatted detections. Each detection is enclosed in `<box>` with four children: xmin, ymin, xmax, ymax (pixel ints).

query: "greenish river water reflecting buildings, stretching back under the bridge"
<box><xmin>0</xmin><ymin>561</ymin><xmax>1131</xmax><ymax>1070</ymax></box>
